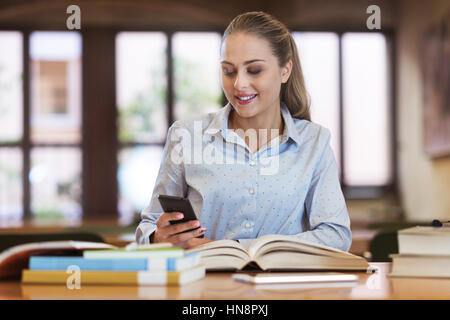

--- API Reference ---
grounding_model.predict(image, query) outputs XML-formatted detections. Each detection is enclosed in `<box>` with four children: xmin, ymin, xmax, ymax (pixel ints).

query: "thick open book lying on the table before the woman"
<box><xmin>187</xmin><ymin>235</ymin><xmax>373</xmax><ymax>271</ymax></box>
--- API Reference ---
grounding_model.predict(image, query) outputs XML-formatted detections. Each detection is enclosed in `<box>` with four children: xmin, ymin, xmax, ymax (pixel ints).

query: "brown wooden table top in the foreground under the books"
<box><xmin>0</xmin><ymin>263</ymin><xmax>450</xmax><ymax>300</ymax></box>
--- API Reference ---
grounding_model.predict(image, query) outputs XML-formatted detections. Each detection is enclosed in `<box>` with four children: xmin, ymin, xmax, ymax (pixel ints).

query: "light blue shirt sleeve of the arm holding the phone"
<box><xmin>135</xmin><ymin>122</ymin><xmax>187</xmax><ymax>244</ymax></box>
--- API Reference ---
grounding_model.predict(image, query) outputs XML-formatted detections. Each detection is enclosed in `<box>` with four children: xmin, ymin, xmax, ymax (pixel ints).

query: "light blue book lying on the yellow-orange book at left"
<box><xmin>29</xmin><ymin>252</ymin><xmax>200</xmax><ymax>271</ymax></box>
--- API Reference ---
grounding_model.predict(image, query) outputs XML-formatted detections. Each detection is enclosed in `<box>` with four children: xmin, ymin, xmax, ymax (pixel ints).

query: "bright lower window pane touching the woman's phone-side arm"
<box><xmin>117</xmin><ymin>146</ymin><xmax>163</xmax><ymax>219</ymax></box>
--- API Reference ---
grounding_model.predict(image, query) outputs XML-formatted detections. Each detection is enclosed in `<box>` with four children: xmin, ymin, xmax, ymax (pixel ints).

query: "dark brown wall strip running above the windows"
<box><xmin>0</xmin><ymin>0</ymin><xmax>396</xmax><ymax>30</ymax></box>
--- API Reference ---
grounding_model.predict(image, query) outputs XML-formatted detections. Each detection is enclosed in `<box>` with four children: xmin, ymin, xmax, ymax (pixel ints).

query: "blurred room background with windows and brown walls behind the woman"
<box><xmin>0</xmin><ymin>0</ymin><xmax>450</xmax><ymax>259</ymax></box>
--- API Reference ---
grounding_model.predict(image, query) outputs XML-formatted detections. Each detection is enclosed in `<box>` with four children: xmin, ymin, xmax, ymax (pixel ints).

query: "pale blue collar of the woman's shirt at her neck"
<box><xmin>205</xmin><ymin>102</ymin><xmax>301</xmax><ymax>144</ymax></box>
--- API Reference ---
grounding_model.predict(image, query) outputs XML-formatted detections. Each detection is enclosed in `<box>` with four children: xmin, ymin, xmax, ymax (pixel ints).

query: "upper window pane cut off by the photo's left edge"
<box><xmin>0</xmin><ymin>31</ymin><xmax>23</xmax><ymax>142</ymax></box>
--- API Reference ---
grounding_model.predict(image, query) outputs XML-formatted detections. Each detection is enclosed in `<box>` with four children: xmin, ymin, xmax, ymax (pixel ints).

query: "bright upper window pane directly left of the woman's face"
<box><xmin>173</xmin><ymin>32</ymin><xmax>222</xmax><ymax>120</ymax></box>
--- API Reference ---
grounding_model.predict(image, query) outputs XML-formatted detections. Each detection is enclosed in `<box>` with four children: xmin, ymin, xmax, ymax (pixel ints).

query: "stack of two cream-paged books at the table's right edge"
<box><xmin>390</xmin><ymin>226</ymin><xmax>450</xmax><ymax>278</ymax></box>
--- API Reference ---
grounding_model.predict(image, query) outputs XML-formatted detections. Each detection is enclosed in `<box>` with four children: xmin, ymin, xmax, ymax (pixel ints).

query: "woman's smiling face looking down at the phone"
<box><xmin>221</xmin><ymin>32</ymin><xmax>292</xmax><ymax>118</ymax></box>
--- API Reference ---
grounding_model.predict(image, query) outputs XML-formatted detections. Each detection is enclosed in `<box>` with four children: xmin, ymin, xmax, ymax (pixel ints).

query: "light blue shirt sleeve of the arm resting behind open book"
<box><xmin>239</xmin><ymin>127</ymin><xmax>352</xmax><ymax>251</ymax></box>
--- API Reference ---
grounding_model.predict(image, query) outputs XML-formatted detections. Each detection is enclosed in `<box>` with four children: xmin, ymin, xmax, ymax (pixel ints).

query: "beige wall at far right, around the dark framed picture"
<box><xmin>397</xmin><ymin>0</ymin><xmax>450</xmax><ymax>221</ymax></box>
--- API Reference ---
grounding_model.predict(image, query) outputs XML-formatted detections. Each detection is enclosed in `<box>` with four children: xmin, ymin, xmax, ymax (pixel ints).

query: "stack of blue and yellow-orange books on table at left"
<box><xmin>22</xmin><ymin>245</ymin><xmax>205</xmax><ymax>286</ymax></box>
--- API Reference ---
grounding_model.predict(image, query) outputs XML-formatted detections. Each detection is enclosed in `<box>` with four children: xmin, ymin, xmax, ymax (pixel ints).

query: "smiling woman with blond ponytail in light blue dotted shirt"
<box><xmin>136</xmin><ymin>12</ymin><xmax>351</xmax><ymax>251</ymax></box>
